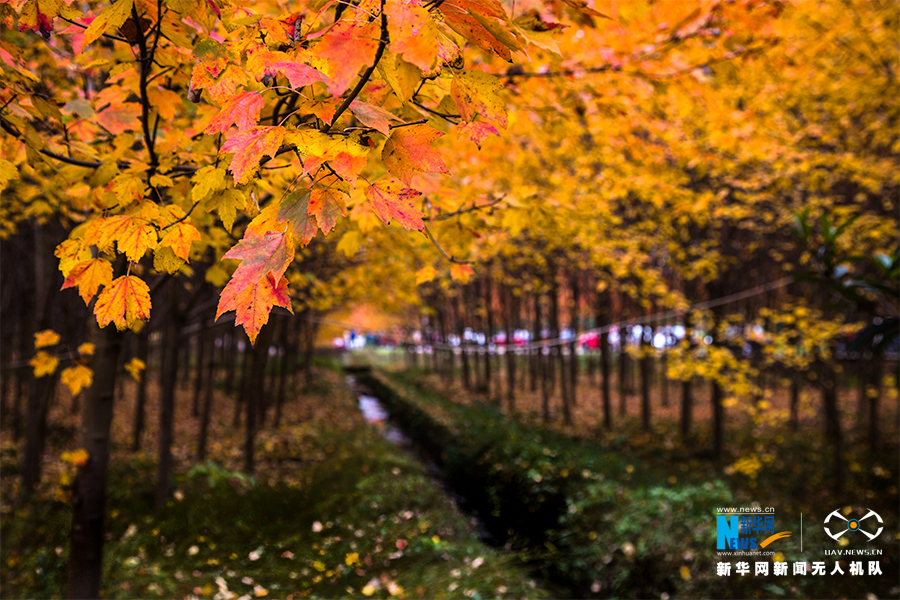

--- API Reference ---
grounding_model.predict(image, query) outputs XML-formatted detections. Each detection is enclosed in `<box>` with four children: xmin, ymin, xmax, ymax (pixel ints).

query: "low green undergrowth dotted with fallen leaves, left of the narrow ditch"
<box><xmin>0</xmin><ymin>390</ymin><xmax>547</xmax><ymax>599</ymax></box>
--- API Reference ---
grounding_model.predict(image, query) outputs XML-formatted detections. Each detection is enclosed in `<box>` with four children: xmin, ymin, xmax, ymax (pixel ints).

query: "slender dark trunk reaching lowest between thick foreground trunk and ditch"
<box><xmin>156</xmin><ymin>277</ymin><xmax>181</xmax><ymax>510</ymax></box>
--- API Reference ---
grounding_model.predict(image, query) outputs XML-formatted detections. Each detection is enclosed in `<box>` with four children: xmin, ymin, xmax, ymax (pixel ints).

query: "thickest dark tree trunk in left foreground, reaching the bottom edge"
<box><xmin>66</xmin><ymin>317</ymin><xmax>122</xmax><ymax>598</ymax></box>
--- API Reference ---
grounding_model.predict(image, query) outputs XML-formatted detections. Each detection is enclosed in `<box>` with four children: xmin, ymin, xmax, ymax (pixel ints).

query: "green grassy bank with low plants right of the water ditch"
<box><xmin>370</xmin><ymin>372</ymin><xmax>900</xmax><ymax>598</ymax></box>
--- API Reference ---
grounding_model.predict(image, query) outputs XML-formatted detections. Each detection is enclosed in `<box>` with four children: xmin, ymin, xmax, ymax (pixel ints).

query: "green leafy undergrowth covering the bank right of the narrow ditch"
<box><xmin>364</xmin><ymin>373</ymin><xmax>898</xmax><ymax>598</ymax></box>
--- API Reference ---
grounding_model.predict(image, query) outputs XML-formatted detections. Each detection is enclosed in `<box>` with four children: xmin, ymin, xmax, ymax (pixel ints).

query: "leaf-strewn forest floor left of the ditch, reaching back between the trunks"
<box><xmin>0</xmin><ymin>368</ymin><xmax>550</xmax><ymax>600</ymax></box>
